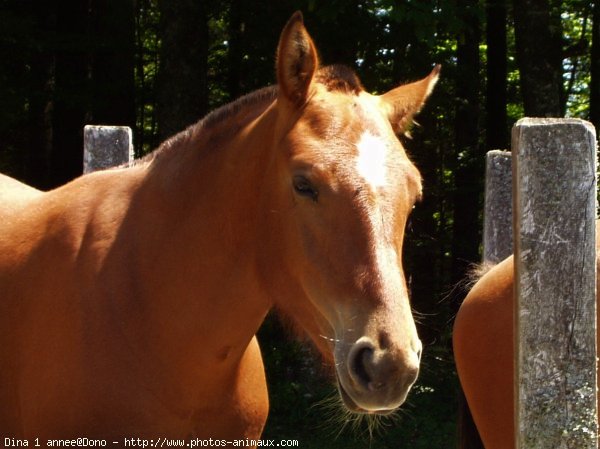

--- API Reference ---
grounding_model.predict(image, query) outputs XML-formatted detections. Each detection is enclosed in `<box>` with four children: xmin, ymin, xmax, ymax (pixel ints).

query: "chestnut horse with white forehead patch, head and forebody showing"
<box><xmin>0</xmin><ymin>13</ymin><xmax>440</xmax><ymax>445</ymax></box>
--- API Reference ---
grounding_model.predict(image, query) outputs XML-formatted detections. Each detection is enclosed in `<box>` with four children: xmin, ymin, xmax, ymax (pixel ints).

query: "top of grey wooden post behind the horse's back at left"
<box><xmin>83</xmin><ymin>125</ymin><xmax>133</xmax><ymax>173</ymax></box>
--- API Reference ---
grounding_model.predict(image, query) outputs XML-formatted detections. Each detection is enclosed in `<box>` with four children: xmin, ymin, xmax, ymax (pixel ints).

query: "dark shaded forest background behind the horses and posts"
<box><xmin>0</xmin><ymin>0</ymin><xmax>600</xmax><ymax>449</ymax></box>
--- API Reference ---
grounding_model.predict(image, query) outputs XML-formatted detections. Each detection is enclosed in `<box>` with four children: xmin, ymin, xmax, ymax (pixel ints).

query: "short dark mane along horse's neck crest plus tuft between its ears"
<box><xmin>130</xmin><ymin>65</ymin><xmax>364</xmax><ymax>167</ymax></box>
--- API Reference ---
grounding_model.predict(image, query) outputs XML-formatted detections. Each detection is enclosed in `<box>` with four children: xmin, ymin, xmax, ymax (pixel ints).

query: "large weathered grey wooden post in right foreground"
<box><xmin>512</xmin><ymin>119</ymin><xmax>598</xmax><ymax>449</ymax></box>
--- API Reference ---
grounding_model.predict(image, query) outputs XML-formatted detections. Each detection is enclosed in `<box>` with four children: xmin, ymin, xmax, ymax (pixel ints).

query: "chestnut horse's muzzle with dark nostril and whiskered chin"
<box><xmin>335</xmin><ymin>336</ymin><xmax>422</xmax><ymax>415</ymax></box>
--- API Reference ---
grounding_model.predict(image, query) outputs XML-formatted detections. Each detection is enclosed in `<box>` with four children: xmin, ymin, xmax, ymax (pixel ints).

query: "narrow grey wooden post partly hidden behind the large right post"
<box><xmin>483</xmin><ymin>150</ymin><xmax>513</xmax><ymax>263</ymax></box>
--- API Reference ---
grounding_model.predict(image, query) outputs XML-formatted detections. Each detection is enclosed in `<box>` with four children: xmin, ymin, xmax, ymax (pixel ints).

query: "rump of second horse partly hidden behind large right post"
<box><xmin>452</xmin><ymin>222</ymin><xmax>600</xmax><ymax>449</ymax></box>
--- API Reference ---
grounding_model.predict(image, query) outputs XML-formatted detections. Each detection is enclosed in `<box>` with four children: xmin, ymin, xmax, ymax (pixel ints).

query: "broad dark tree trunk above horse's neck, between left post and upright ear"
<box><xmin>157</xmin><ymin>0</ymin><xmax>209</xmax><ymax>140</ymax></box>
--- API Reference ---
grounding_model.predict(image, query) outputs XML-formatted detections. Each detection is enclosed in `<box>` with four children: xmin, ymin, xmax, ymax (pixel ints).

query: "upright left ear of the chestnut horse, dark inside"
<box><xmin>277</xmin><ymin>11</ymin><xmax>319</xmax><ymax>105</ymax></box>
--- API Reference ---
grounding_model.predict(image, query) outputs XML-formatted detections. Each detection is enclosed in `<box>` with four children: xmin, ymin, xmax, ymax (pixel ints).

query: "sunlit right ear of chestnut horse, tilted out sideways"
<box><xmin>380</xmin><ymin>64</ymin><xmax>442</xmax><ymax>134</ymax></box>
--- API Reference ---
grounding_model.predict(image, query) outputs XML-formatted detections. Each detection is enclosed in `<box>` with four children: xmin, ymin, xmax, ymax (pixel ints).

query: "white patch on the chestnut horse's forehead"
<box><xmin>356</xmin><ymin>131</ymin><xmax>388</xmax><ymax>189</ymax></box>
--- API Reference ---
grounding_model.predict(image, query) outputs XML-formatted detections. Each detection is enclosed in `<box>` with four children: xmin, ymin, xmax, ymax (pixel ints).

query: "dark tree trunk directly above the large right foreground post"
<box><xmin>513</xmin><ymin>0</ymin><xmax>565</xmax><ymax>117</ymax></box>
